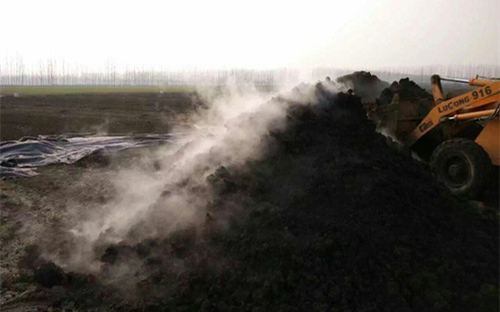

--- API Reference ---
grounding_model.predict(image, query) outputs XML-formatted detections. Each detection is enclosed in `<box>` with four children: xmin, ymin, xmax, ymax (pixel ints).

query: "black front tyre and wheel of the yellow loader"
<box><xmin>430</xmin><ymin>138</ymin><xmax>492</xmax><ymax>199</ymax></box>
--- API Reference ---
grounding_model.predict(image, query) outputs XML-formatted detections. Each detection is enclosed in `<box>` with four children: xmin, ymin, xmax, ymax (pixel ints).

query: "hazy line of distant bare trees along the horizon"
<box><xmin>0</xmin><ymin>57</ymin><xmax>500</xmax><ymax>86</ymax></box>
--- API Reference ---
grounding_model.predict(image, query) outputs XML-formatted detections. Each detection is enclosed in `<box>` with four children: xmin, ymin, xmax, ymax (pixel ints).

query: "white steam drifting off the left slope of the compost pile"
<box><xmin>48</xmin><ymin>78</ymin><xmax>336</xmax><ymax>272</ymax></box>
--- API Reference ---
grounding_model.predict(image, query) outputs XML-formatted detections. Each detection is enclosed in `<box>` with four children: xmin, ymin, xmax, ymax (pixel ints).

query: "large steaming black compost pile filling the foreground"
<box><xmin>20</xmin><ymin>84</ymin><xmax>499</xmax><ymax>311</ymax></box>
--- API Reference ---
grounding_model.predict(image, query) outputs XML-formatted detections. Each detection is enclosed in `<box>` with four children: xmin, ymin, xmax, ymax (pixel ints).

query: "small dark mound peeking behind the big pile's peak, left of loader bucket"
<box><xmin>337</xmin><ymin>71</ymin><xmax>389</xmax><ymax>103</ymax></box>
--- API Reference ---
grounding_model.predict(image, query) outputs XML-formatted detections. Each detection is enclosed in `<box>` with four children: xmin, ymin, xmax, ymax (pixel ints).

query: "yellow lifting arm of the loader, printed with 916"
<box><xmin>404</xmin><ymin>76</ymin><xmax>500</xmax><ymax>146</ymax></box>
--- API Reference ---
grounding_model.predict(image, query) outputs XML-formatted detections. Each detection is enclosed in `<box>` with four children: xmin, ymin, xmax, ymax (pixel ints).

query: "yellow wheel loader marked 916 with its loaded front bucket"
<box><xmin>382</xmin><ymin>75</ymin><xmax>500</xmax><ymax>198</ymax></box>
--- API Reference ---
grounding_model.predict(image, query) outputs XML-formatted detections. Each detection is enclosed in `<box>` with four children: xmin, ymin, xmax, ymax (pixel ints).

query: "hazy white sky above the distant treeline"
<box><xmin>0</xmin><ymin>0</ymin><xmax>500</xmax><ymax>68</ymax></box>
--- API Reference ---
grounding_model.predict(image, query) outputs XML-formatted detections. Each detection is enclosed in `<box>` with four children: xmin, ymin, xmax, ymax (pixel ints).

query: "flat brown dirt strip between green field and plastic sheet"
<box><xmin>0</xmin><ymin>93</ymin><xmax>200</xmax><ymax>141</ymax></box>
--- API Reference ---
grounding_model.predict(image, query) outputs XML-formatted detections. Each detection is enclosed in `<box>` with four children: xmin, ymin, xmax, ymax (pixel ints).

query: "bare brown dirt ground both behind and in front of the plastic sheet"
<box><xmin>0</xmin><ymin>93</ymin><xmax>201</xmax><ymax>311</ymax></box>
